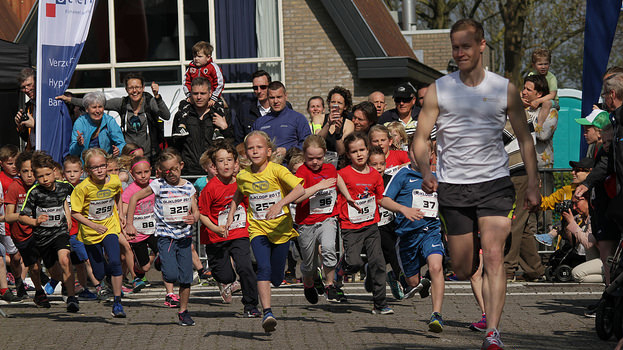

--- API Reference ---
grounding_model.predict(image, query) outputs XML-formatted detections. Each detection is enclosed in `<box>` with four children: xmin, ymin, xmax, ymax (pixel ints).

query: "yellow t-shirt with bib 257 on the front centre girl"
<box><xmin>236</xmin><ymin>162</ymin><xmax>303</xmax><ymax>244</ymax></box>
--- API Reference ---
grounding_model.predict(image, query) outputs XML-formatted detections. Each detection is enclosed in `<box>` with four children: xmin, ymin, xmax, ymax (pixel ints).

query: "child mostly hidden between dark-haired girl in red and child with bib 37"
<box><xmin>364</xmin><ymin>146</ymin><xmax>407</xmax><ymax>300</ymax></box>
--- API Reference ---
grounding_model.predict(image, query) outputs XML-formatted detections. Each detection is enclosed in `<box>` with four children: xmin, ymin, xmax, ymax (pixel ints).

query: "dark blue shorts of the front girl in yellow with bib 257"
<box><xmin>251</xmin><ymin>236</ymin><xmax>290</xmax><ymax>287</ymax></box>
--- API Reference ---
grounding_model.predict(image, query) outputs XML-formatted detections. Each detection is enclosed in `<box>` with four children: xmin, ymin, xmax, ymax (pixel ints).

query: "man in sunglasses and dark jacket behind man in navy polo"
<box><xmin>232</xmin><ymin>70</ymin><xmax>292</xmax><ymax>145</ymax></box>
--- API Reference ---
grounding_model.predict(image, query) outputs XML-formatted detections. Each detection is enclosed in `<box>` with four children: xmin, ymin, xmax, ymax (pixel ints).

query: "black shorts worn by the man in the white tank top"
<box><xmin>437</xmin><ymin>176</ymin><xmax>515</xmax><ymax>235</ymax></box>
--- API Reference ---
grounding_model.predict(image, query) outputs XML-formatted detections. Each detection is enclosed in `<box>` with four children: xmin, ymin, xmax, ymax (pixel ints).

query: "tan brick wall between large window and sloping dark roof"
<box><xmin>283</xmin><ymin>0</ymin><xmax>395</xmax><ymax>115</ymax></box>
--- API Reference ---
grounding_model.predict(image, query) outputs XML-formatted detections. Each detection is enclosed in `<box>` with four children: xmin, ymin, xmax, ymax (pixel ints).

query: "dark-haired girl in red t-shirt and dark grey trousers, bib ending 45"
<box><xmin>338</xmin><ymin>132</ymin><xmax>394</xmax><ymax>315</ymax></box>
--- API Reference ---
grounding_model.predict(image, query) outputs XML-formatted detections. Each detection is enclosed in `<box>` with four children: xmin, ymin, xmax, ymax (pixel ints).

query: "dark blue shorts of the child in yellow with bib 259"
<box><xmin>84</xmin><ymin>234</ymin><xmax>123</xmax><ymax>281</ymax></box>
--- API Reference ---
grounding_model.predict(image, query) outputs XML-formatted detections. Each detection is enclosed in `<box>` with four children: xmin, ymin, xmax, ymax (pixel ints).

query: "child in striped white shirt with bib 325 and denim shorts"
<box><xmin>126</xmin><ymin>148</ymin><xmax>199</xmax><ymax>326</ymax></box>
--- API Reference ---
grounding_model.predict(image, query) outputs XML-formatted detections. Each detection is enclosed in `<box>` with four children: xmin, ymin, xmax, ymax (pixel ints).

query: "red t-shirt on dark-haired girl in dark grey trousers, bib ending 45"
<box><xmin>338</xmin><ymin>165</ymin><xmax>385</xmax><ymax>229</ymax></box>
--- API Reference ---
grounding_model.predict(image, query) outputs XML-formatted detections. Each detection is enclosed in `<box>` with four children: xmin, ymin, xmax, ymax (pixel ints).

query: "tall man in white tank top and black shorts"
<box><xmin>413</xmin><ymin>19</ymin><xmax>540</xmax><ymax>350</ymax></box>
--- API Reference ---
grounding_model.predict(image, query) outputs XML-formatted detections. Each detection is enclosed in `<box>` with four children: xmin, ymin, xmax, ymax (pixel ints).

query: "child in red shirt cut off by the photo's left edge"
<box><xmin>0</xmin><ymin>144</ymin><xmax>28</xmax><ymax>298</ymax></box>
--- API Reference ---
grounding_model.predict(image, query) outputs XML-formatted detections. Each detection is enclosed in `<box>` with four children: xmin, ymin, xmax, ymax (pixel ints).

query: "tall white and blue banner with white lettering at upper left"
<box><xmin>35</xmin><ymin>0</ymin><xmax>95</xmax><ymax>163</ymax></box>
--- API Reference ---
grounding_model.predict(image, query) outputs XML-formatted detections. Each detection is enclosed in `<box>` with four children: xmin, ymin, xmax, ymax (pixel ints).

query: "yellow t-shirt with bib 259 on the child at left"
<box><xmin>71</xmin><ymin>175</ymin><xmax>122</xmax><ymax>244</ymax></box>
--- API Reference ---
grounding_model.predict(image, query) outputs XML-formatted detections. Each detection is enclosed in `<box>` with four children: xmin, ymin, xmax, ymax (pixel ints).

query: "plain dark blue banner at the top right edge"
<box><xmin>580</xmin><ymin>0</ymin><xmax>621</xmax><ymax>157</ymax></box>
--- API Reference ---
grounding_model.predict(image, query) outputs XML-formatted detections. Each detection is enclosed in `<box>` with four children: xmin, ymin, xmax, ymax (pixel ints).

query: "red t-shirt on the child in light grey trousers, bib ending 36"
<box><xmin>295</xmin><ymin>163</ymin><xmax>338</xmax><ymax>225</ymax></box>
